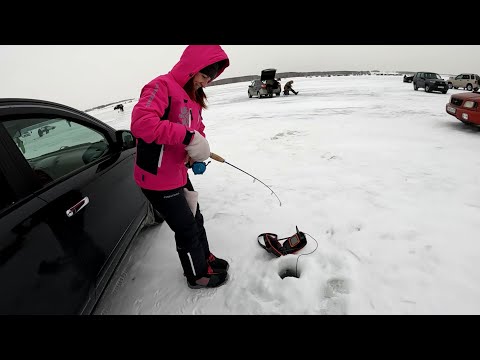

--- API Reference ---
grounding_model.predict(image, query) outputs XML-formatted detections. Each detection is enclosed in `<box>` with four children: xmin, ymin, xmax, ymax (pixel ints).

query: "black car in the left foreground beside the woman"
<box><xmin>0</xmin><ymin>99</ymin><xmax>162</xmax><ymax>314</ymax></box>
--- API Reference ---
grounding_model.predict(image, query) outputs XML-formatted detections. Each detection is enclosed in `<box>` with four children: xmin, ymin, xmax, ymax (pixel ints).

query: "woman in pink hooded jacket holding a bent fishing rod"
<box><xmin>131</xmin><ymin>45</ymin><xmax>230</xmax><ymax>289</ymax></box>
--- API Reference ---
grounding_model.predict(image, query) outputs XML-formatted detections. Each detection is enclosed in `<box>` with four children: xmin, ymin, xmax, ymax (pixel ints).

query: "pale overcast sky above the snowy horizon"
<box><xmin>0</xmin><ymin>45</ymin><xmax>480</xmax><ymax>110</ymax></box>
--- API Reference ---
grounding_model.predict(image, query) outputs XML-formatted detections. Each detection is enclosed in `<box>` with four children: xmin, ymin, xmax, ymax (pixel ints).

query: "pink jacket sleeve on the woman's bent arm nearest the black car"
<box><xmin>130</xmin><ymin>80</ymin><xmax>191</xmax><ymax>145</ymax></box>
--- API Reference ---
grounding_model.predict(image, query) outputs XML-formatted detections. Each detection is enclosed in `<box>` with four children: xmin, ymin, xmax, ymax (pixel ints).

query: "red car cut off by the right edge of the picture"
<box><xmin>445</xmin><ymin>92</ymin><xmax>480</xmax><ymax>125</ymax></box>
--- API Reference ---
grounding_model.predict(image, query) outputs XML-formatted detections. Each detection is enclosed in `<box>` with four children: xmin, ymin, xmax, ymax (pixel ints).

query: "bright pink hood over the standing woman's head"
<box><xmin>170</xmin><ymin>45</ymin><xmax>230</xmax><ymax>87</ymax></box>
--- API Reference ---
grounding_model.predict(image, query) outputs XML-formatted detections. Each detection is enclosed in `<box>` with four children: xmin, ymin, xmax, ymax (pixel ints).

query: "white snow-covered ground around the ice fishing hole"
<box><xmin>91</xmin><ymin>76</ymin><xmax>480</xmax><ymax>314</ymax></box>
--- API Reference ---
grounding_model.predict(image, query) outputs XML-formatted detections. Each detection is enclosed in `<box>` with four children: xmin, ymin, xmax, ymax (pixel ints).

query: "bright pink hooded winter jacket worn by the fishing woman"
<box><xmin>131</xmin><ymin>45</ymin><xmax>230</xmax><ymax>190</ymax></box>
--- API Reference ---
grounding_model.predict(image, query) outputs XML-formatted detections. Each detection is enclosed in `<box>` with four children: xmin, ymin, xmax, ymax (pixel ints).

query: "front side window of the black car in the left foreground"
<box><xmin>4</xmin><ymin>118</ymin><xmax>109</xmax><ymax>185</ymax></box>
